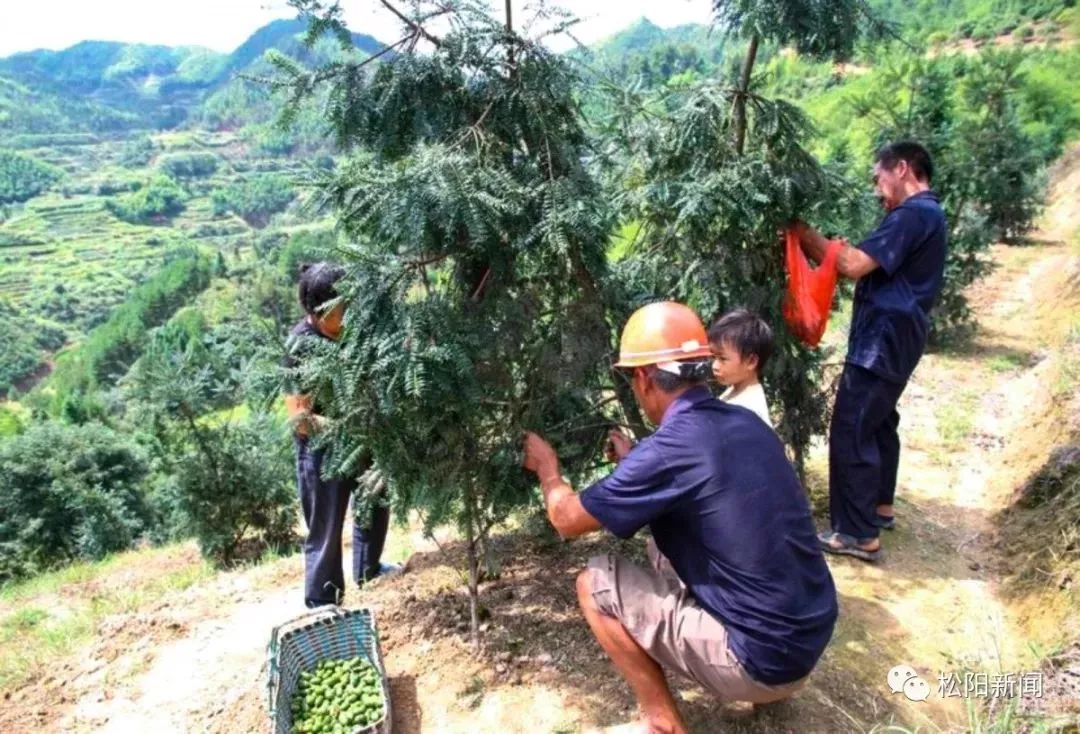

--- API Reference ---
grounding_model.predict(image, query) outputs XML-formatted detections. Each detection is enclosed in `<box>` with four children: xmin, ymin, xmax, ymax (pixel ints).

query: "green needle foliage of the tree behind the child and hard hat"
<box><xmin>608</xmin><ymin>82</ymin><xmax>846</xmax><ymax>470</ymax></box>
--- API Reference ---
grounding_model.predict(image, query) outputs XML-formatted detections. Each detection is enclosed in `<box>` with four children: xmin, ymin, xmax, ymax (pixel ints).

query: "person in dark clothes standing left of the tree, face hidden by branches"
<box><xmin>283</xmin><ymin>262</ymin><xmax>397</xmax><ymax>607</ymax></box>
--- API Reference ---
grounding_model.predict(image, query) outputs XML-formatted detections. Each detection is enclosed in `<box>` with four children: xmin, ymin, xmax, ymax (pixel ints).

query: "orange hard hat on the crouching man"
<box><xmin>615</xmin><ymin>301</ymin><xmax>712</xmax><ymax>373</ymax></box>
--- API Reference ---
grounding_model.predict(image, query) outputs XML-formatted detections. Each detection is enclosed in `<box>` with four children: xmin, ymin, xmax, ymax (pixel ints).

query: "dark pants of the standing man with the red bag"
<box><xmin>828</xmin><ymin>365</ymin><xmax>906</xmax><ymax>540</ymax></box>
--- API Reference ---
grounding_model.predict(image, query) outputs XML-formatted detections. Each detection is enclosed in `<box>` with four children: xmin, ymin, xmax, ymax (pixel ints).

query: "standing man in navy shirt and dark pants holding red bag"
<box><xmin>798</xmin><ymin>142</ymin><xmax>947</xmax><ymax>561</ymax></box>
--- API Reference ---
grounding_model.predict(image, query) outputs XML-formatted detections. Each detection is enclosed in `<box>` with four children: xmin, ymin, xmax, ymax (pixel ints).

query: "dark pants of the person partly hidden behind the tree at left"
<box><xmin>296</xmin><ymin>437</ymin><xmax>390</xmax><ymax>607</ymax></box>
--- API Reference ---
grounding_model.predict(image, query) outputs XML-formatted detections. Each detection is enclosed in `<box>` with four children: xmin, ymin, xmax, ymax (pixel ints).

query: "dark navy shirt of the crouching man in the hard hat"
<box><xmin>581</xmin><ymin>388</ymin><xmax>837</xmax><ymax>685</ymax></box>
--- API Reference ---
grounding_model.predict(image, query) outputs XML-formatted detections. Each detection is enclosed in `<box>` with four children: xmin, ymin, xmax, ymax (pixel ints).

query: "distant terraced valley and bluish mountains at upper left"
<box><xmin>0</xmin><ymin>21</ymin><xmax>395</xmax><ymax>394</ymax></box>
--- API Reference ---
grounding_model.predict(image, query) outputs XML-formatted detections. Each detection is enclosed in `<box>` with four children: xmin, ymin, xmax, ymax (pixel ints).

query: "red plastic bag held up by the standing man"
<box><xmin>784</xmin><ymin>229</ymin><xmax>841</xmax><ymax>346</ymax></box>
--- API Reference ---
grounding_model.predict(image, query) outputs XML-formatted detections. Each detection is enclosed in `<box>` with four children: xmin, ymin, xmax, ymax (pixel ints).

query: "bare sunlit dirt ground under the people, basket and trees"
<box><xmin>0</xmin><ymin>151</ymin><xmax>1080</xmax><ymax>734</ymax></box>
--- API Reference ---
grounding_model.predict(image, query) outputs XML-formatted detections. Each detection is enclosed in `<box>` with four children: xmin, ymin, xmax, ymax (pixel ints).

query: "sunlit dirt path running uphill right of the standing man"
<box><xmin>816</xmin><ymin>236</ymin><xmax>1078</xmax><ymax>728</ymax></box>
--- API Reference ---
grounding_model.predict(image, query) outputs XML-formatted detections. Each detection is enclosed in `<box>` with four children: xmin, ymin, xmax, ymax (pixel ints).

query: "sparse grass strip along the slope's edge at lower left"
<box><xmin>0</xmin><ymin>545</ymin><xmax>215</xmax><ymax>691</ymax></box>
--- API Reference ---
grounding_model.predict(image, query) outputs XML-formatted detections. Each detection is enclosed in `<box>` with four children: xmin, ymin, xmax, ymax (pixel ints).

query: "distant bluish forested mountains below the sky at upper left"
<box><xmin>0</xmin><ymin>19</ymin><xmax>382</xmax><ymax>134</ymax></box>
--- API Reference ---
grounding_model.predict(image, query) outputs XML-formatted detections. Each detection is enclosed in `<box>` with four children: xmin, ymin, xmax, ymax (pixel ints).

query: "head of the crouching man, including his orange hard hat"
<box><xmin>616</xmin><ymin>301</ymin><xmax>711</xmax><ymax>424</ymax></box>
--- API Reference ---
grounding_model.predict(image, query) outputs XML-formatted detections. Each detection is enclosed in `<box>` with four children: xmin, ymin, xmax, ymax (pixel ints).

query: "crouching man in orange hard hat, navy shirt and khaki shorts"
<box><xmin>525</xmin><ymin>302</ymin><xmax>837</xmax><ymax>733</ymax></box>
